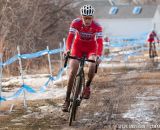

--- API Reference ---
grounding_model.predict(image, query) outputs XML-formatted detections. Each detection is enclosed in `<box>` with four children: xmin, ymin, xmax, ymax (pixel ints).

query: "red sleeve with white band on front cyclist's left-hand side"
<box><xmin>66</xmin><ymin>20</ymin><xmax>77</xmax><ymax>50</ymax></box>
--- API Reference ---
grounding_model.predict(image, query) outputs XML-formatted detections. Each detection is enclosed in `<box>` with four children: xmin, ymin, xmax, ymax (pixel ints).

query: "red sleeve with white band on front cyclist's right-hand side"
<box><xmin>96</xmin><ymin>26</ymin><xmax>103</xmax><ymax>56</ymax></box>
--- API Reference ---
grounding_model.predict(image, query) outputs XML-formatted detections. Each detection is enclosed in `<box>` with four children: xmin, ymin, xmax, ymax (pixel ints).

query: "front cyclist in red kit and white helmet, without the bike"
<box><xmin>62</xmin><ymin>5</ymin><xmax>103</xmax><ymax>112</ymax></box>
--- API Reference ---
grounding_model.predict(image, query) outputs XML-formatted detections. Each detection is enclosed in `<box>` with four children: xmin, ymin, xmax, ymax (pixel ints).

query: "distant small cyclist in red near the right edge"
<box><xmin>147</xmin><ymin>30</ymin><xmax>159</xmax><ymax>58</ymax></box>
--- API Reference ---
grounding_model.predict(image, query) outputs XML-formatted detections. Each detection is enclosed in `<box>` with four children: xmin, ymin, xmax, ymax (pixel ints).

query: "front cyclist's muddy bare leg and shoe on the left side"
<box><xmin>62</xmin><ymin>59</ymin><xmax>79</xmax><ymax>112</ymax></box>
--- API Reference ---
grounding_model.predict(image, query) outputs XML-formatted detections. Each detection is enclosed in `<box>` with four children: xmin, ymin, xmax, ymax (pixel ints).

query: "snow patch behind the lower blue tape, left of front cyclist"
<box><xmin>1</xmin><ymin>76</ymin><xmax>67</xmax><ymax>100</ymax></box>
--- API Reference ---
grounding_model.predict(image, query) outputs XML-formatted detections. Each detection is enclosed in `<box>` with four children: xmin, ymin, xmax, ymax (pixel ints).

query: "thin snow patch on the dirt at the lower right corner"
<box><xmin>123</xmin><ymin>88</ymin><xmax>160</xmax><ymax>124</ymax></box>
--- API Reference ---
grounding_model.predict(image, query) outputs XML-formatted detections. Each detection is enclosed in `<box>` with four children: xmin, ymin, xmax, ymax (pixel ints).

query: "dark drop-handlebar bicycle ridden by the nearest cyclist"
<box><xmin>64</xmin><ymin>53</ymin><xmax>98</xmax><ymax>126</ymax></box>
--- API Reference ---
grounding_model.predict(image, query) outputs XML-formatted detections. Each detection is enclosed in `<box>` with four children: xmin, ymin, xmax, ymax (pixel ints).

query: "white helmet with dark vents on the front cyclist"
<box><xmin>80</xmin><ymin>5</ymin><xmax>95</xmax><ymax>16</ymax></box>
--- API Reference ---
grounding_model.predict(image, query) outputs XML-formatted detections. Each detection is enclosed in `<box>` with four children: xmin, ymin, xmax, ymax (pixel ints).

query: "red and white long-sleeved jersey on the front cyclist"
<box><xmin>66</xmin><ymin>18</ymin><xmax>103</xmax><ymax>56</ymax></box>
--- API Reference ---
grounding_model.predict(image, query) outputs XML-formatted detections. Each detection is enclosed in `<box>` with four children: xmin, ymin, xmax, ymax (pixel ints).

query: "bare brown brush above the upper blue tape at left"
<box><xmin>0</xmin><ymin>0</ymin><xmax>75</xmax><ymax>76</ymax></box>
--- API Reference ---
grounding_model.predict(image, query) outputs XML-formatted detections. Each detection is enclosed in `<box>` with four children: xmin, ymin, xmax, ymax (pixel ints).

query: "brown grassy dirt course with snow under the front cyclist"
<box><xmin>0</xmin><ymin>61</ymin><xmax>160</xmax><ymax>130</ymax></box>
